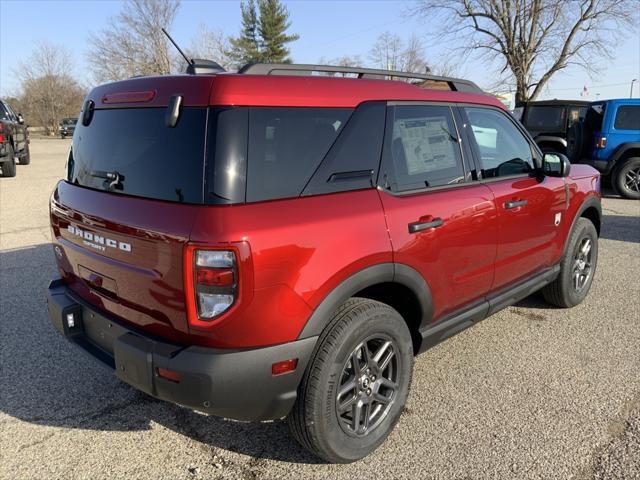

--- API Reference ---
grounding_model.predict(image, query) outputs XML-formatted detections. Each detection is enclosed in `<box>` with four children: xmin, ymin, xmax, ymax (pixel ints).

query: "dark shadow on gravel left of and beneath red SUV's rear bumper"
<box><xmin>0</xmin><ymin>244</ymin><xmax>321</xmax><ymax>463</ymax></box>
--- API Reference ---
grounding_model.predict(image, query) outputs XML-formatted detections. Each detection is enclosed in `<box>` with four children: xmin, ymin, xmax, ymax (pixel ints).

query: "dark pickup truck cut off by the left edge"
<box><xmin>0</xmin><ymin>100</ymin><xmax>31</xmax><ymax>177</ymax></box>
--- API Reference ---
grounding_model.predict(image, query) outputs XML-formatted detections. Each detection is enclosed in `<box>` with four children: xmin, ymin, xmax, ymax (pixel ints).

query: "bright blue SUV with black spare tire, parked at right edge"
<box><xmin>567</xmin><ymin>98</ymin><xmax>640</xmax><ymax>199</ymax></box>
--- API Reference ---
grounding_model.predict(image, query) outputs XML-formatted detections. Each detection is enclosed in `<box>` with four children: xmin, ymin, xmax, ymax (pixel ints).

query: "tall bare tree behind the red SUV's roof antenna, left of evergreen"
<box><xmin>87</xmin><ymin>0</ymin><xmax>180</xmax><ymax>82</ymax></box>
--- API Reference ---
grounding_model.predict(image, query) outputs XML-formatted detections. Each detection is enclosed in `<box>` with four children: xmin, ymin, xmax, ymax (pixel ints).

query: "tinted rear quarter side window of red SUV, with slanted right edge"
<box><xmin>247</xmin><ymin>108</ymin><xmax>352</xmax><ymax>202</ymax></box>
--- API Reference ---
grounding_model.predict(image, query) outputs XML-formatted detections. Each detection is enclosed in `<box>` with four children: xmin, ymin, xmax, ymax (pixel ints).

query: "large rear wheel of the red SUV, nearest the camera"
<box><xmin>288</xmin><ymin>298</ymin><xmax>413</xmax><ymax>463</ymax></box>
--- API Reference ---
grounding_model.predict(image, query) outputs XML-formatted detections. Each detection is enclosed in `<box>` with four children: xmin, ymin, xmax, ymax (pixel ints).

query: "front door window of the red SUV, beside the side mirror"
<box><xmin>464</xmin><ymin>107</ymin><xmax>535</xmax><ymax>178</ymax></box>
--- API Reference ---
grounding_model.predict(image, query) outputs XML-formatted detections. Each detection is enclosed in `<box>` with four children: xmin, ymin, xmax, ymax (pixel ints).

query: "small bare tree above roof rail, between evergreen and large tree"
<box><xmin>369</xmin><ymin>32</ymin><xmax>428</xmax><ymax>73</ymax></box>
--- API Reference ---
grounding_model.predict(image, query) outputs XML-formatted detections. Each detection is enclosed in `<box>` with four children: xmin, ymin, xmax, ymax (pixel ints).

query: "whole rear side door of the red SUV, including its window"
<box><xmin>378</xmin><ymin>102</ymin><xmax>497</xmax><ymax>321</ymax></box>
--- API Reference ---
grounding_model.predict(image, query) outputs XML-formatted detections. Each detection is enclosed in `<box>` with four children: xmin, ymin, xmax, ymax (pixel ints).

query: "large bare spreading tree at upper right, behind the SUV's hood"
<box><xmin>419</xmin><ymin>0</ymin><xmax>638</xmax><ymax>102</ymax></box>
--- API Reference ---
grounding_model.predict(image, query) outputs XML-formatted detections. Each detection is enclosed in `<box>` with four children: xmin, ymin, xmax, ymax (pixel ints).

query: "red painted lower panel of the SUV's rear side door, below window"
<box><xmin>380</xmin><ymin>184</ymin><xmax>498</xmax><ymax>321</ymax></box>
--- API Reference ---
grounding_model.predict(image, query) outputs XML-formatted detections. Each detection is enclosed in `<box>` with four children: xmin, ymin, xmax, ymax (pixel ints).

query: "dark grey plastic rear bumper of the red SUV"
<box><xmin>47</xmin><ymin>280</ymin><xmax>317</xmax><ymax>421</ymax></box>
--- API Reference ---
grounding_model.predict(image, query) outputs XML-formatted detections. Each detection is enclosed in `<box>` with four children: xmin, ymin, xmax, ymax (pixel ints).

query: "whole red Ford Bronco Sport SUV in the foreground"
<box><xmin>48</xmin><ymin>65</ymin><xmax>601</xmax><ymax>462</ymax></box>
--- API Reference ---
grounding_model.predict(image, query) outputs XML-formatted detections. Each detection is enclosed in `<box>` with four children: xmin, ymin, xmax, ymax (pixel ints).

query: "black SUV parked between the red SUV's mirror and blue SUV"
<box><xmin>520</xmin><ymin>100</ymin><xmax>589</xmax><ymax>153</ymax></box>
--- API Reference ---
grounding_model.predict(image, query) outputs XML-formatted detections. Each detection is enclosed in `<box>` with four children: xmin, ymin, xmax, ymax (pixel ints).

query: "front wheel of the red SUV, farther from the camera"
<box><xmin>542</xmin><ymin>218</ymin><xmax>598</xmax><ymax>308</ymax></box>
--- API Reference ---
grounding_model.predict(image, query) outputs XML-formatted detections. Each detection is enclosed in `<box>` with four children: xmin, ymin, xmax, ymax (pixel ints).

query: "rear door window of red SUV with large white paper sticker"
<box><xmin>382</xmin><ymin>105</ymin><xmax>464</xmax><ymax>192</ymax></box>
